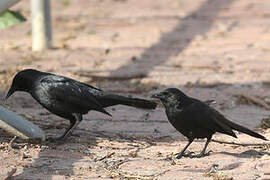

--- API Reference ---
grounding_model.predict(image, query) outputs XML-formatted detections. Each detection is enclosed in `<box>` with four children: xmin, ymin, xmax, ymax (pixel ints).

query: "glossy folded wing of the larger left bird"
<box><xmin>40</xmin><ymin>75</ymin><xmax>110</xmax><ymax>115</ymax></box>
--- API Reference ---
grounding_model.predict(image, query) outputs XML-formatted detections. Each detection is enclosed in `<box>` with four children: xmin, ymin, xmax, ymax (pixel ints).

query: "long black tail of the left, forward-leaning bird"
<box><xmin>100</xmin><ymin>94</ymin><xmax>157</xmax><ymax>109</ymax></box>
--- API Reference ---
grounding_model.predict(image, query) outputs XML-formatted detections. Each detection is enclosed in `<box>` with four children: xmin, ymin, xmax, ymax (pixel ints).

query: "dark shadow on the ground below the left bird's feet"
<box><xmin>10</xmin><ymin>137</ymin><xmax>98</xmax><ymax>179</ymax></box>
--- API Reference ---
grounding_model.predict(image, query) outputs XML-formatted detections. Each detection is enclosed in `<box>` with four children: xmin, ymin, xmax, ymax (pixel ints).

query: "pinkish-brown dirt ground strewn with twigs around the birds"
<box><xmin>0</xmin><ymin>0</ymin><xmax>270</xmax><ymax>180</ymax></box>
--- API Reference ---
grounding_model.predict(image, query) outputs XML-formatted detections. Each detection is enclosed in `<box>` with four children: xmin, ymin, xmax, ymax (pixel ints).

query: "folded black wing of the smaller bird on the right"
<box><xmin>184</xmin><ymin>101</ymin><xmax>236</xmax><ymax>137</ymax></box>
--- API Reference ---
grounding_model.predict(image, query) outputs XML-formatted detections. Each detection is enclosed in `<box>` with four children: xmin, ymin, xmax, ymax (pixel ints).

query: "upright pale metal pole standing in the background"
<box><xmin>31</xmin><ymin>0</ymin><xmax>52</xmax><ymax>51</ymax></box>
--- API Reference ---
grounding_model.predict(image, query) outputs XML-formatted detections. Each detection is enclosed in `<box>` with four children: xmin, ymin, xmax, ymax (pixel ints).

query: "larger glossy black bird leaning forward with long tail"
<box><xmin>6</xmin><ymin>69</ymin><xmax>156</xmax><ymax>140</ymax></box>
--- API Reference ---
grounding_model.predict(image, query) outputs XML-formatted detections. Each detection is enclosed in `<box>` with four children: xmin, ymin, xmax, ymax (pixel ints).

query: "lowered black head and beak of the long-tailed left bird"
<box><xmin>5</xmin><ymin>69</ymin><xmax>38</xmax><ymax>100</ymax></box>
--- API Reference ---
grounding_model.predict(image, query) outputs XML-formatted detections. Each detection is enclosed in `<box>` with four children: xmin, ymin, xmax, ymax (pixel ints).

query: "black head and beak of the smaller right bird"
<box><xmin>151</xmin><ymin>88</ymin><xmax>189</xmax><ymax>107</ymax></box>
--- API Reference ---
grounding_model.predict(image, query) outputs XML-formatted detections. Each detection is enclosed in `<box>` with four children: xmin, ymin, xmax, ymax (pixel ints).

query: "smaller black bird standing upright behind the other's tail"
<box><xmin>152</xmin><ymin>88</ymin><xmax>267</xmax><ymax>159</ymax></box>
